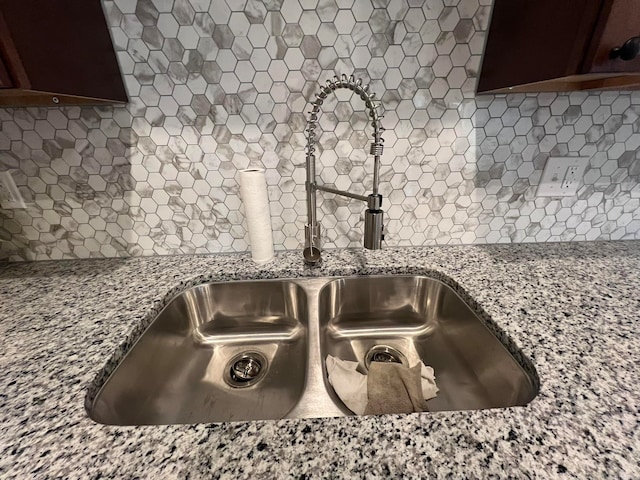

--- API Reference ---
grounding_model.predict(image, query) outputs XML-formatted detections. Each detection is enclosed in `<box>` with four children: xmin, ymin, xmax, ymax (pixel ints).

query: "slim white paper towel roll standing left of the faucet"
<box><xmin>240</xmin><ymin>168</ymin><xmax>274</xmax><ymax>265</ymax></box>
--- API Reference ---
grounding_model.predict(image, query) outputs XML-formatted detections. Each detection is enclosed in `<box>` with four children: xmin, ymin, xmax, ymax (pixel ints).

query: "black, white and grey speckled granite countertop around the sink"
<box><xmin>0</xmin><ymin>241</ymin><xmax>640</xmax><ymax>479</ymax></box>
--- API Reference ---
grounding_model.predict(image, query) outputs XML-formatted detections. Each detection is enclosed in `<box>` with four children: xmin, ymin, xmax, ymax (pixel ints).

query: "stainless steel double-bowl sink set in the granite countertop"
<box><xmin>88</xmin><ymin>275</ymin><xmax>539</xmax><ymax>425</ymax></box>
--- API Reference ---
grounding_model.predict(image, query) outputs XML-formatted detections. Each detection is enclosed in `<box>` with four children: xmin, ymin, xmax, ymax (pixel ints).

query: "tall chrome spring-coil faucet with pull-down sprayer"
<box><xmin>303</xmin><ymin>74</ymin><xmax>384</xmax><ymax>265</ymax></box>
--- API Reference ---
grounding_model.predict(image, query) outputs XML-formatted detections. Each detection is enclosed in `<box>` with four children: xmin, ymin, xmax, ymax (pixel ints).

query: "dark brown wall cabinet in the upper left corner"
<box><xmin>0</xmin><ymin>0</ymin><xmax>127</xmax><ymax>106</ymax></box>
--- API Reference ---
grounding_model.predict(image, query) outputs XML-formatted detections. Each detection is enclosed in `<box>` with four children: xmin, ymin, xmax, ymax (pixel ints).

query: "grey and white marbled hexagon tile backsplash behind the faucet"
<box><xmin>0</xmin><ymin>0</ymin><xmax>640</xmax><ymax>260</ymax></box>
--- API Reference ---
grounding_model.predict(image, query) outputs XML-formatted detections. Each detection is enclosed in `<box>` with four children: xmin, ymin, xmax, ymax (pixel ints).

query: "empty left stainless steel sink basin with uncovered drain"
<box><xmin>89</xmin><ymin>280</ymin><xmax>308</xmax><ymax>425</ymax></box>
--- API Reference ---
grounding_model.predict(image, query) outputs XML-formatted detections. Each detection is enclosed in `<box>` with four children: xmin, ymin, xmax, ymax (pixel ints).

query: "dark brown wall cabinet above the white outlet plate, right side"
<box><xmin>478</xmin><ymin>0</ymin><xmax>640</xmax><ymax>93</ymax></box>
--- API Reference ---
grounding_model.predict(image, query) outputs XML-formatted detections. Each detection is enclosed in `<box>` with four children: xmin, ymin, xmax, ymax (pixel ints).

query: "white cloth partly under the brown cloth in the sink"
<box><xmin>325</xmin><ymin>355</ymin><xmax>438</xmax><ymax>415</ymax></box>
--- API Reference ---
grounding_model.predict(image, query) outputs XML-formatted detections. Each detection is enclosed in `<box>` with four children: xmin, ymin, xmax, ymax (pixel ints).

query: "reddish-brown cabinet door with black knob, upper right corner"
<box><xmin>583</xmin><ymin>0</ymin><xmax>640</xmax><ymax>73</ymax></box>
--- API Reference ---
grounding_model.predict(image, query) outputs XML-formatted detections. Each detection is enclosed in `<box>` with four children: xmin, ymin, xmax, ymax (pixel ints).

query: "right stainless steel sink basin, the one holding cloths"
<box><xmin>319</xmin><ymin>276</ymin><xmax>537</xmax><ymax>413</ymax></box>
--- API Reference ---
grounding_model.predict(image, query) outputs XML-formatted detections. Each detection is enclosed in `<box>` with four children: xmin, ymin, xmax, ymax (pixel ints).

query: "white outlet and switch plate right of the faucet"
<box><xmin>537</xmin><ymin>157</ymin><xmax>589</xmax><ymax>197</ymax></box>
